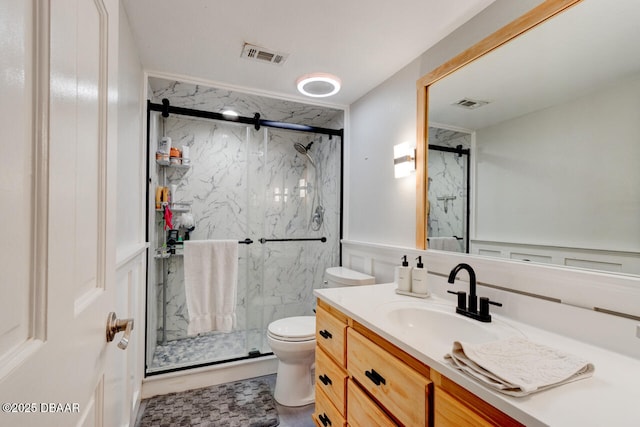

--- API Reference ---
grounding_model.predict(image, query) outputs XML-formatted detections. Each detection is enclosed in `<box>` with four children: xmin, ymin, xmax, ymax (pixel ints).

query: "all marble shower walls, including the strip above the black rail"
<box><xmin>154</xmin><ymin>78</ymin><xmax>342</xmax><ymax>351</ymax></box>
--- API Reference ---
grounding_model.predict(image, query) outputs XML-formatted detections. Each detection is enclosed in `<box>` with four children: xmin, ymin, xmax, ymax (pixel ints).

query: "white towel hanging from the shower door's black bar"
<box><xmin>184</xmin><ymin>240</ymin><xmax>238</xmax><ymax>335</ymax></box>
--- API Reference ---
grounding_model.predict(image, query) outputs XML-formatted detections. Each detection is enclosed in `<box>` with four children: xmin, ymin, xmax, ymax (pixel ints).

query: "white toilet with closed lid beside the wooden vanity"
<box><xmin>267</xmin><ymin>267</ymin><xmax>375</xmax><ymax>406</ymax></box>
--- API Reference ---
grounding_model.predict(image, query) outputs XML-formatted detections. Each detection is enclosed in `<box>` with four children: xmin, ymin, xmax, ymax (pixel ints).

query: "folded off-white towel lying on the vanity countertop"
<box><xmin>445</xmin><ymin>337</ymin><xmax>595</xmax><ymax>397</ymax></box>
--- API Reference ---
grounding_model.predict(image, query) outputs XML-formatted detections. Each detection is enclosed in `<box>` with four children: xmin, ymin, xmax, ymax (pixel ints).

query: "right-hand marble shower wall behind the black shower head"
<box><xmin>256</xmin><ymin>129</ymin><xmax>340</xmax><ymax>352</ymax></box>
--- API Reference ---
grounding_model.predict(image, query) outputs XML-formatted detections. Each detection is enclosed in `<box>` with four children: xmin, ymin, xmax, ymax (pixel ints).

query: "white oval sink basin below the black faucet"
<box><xmin>379</xmin><ymin>301</ymin><xmax>524</xmax><ymax>349</ymax></box>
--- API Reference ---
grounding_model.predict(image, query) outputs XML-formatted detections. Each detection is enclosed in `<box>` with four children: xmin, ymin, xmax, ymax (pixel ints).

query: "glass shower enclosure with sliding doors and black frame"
<box><xmin>146</xmin><ymin>105</ymin><xmax>342</xmax><ymax>375</ymax></box>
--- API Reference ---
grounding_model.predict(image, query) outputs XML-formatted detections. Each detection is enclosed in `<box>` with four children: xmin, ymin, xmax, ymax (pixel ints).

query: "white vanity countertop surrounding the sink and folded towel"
<box><xmin>314</xmin><ymin>283</ymin><xmax>640</xmax><ymax>427</ymax></box>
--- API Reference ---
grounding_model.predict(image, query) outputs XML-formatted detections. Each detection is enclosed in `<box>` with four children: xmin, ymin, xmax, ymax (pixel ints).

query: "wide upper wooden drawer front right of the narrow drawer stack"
<box><xmin>347</xmin><ymin>328</ymin><xmax>431</xmax><ymax>426</ymax></box>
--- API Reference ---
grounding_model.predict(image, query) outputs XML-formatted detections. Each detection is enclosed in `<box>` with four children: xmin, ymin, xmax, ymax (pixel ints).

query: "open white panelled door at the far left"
<box><xmin>0</xmin><ymin>0</ymin><xmax>130</xmax><ymax>426</ymax></box>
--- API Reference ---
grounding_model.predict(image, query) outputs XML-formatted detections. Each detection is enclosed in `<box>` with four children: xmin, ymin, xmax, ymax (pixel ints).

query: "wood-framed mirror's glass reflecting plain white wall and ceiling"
<box><xmin>427</xmin><ymin>0</ymin><xmax>640</xmax><ymax>274</ymax></box>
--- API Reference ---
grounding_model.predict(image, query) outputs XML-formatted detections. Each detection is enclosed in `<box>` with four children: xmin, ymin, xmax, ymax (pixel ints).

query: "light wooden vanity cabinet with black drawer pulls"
<box><xmin>313</xmin><ymin>300</ymin><xmax>522</xmax><ymax>427</ymax></box>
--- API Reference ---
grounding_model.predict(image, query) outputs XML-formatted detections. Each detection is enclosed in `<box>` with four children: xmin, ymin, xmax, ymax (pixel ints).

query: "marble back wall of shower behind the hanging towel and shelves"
<box><xmin>157</xmin><ymin>115</ymin><xmax>250</xmax><ymax>341</ymax></box>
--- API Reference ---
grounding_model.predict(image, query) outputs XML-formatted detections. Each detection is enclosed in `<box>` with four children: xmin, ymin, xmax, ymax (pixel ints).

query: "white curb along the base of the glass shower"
<box><xmin>142</xmin><ymin>356</ymin><xmax>278</xmax><ymax>399</ymax></box>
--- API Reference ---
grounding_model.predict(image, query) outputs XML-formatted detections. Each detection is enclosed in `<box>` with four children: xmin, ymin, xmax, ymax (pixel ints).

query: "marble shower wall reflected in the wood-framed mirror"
<box><xmin>427</xmin><ymin>128</ymin><xmax>471</xmax><ymax>252</ymax></box>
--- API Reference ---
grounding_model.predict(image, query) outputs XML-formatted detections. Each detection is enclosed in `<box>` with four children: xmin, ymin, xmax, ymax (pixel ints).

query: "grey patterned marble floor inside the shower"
<box><xmin>147</xmin><ymin>330</ymin><xmax>270</xmax><ymax>373</ymax></box>
